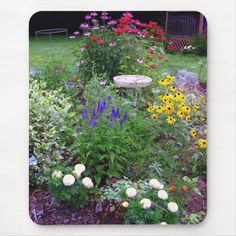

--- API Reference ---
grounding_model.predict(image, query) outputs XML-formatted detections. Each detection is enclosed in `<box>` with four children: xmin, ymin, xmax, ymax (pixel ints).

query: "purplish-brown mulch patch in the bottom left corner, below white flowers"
<box><xmin>29</xmin><ymin>189</ymin><xmax>122</xmax><ymax>225</ymax></box>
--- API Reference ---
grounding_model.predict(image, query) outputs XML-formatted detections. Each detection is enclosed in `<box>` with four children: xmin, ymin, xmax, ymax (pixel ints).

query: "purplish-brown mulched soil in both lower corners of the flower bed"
<box><xmin>29</xmin><ymin>178</ymin><xmax>207</xmax><ymax>225</ymax></box>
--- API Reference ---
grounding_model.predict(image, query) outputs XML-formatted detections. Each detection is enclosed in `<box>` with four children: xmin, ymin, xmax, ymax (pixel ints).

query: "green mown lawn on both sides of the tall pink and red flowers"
<box><xmin>29</xmin><ymin>36</ymin><xmax>207</xmax><ymax>83</ymax></box>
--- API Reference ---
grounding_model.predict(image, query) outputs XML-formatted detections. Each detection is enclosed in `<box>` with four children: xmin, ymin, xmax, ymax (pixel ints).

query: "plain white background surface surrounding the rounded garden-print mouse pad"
<box><xmin>0</xmin><ymin>0</ymin><xmax>236</xmax><ymax>236</ymax></box>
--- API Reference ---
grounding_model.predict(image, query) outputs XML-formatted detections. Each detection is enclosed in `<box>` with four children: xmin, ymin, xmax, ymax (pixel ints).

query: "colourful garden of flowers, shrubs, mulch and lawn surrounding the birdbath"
<box><xmin>29</xmin><ymin>12</ymin><xmax>207</xmax><ymax>225</ymax></box>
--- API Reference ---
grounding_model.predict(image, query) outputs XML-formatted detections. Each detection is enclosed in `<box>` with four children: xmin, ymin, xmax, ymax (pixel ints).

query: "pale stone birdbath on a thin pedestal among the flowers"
<box><xmin>113</xmin><ymin>75</ymin><xmax>152</xmax><ymax>107</ymax></box>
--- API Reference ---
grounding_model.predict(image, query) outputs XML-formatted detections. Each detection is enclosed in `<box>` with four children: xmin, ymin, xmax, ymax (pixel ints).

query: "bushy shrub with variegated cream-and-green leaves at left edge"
<box><xmin>29</xmin><ymin>80</ymin><xmax>75</xmax><ymax>185</ymax></box>
